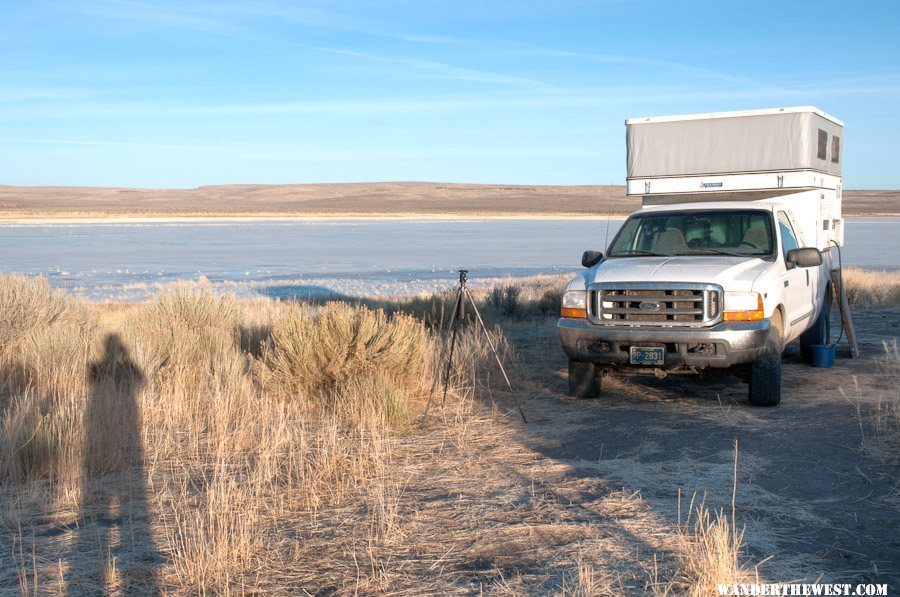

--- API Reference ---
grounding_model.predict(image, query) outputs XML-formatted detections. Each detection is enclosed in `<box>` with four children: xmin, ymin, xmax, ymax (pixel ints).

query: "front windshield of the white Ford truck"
<box><xmin>607</xmin><ymin>209</ymin><xmax>774</xmax><ymax>257</ymax></box>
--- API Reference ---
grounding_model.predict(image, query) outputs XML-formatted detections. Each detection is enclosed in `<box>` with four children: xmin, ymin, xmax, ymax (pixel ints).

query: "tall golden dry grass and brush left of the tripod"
<box><xmin>0</xmin><ymin>278</ymin><xmax>509</xmax><ymax>594</ymax></box>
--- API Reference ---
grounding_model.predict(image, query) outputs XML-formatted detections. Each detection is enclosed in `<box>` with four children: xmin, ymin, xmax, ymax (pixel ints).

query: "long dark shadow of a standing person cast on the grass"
<box><xmin>68</xmin><ymin>334</ymin><xmax>163</xmax><ymax>595</ymax></box>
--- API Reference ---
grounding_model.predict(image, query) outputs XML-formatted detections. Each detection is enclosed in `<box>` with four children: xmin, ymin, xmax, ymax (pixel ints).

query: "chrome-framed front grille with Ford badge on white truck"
<box><xmin>589</xmin><ymin>283</ymin><xmax>722</xmax><ymax>327</ymax></box>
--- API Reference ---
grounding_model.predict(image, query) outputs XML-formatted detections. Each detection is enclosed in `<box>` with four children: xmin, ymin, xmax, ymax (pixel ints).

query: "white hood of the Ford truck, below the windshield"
<box><xmin>585</xmin><ymin>255</ymin><xmax>772</xmax><ymax>291</ymax></box>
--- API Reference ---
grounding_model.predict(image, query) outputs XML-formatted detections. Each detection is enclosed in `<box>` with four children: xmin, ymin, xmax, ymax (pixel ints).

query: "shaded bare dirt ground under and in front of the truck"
<box><xmin>472</xmin><ymin>309</ymin><xmax>900</xmax><ymax>590</ymax></box>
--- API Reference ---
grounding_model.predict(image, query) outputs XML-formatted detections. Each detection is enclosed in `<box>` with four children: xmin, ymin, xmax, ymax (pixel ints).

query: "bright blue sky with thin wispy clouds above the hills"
<box><xmin>0</xmin><ymin>0</ymin><xmax>900</xmax><ymax>188</ymax></box>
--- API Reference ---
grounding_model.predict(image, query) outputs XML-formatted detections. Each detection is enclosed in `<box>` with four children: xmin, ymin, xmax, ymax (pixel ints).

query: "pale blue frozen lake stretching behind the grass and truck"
<box><xmin>0</xmin><ymin>218</ymin><xmax>900</xmax><ymax>300</ymax></box>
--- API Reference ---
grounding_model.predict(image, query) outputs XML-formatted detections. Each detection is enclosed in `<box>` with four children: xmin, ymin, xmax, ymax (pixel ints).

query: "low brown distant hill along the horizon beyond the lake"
<box><xmin>0</xmin><ymin>182</ymin><xmax>900</xmax><ymax>219</ymax></box>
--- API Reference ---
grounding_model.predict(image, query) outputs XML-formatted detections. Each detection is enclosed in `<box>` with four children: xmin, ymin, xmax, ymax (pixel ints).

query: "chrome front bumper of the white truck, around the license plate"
<box><xmin>557</xmin><ymin>317</ymin><xmax>769</xmax><ymax>369</ymax></box>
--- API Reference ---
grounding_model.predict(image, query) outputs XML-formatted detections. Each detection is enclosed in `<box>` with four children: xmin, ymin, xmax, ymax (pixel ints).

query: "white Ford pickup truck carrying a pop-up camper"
<box><xmin>558</xmin><ymin>107</ymin><xmax>843</xmax><ymax>406</ymax></box>
